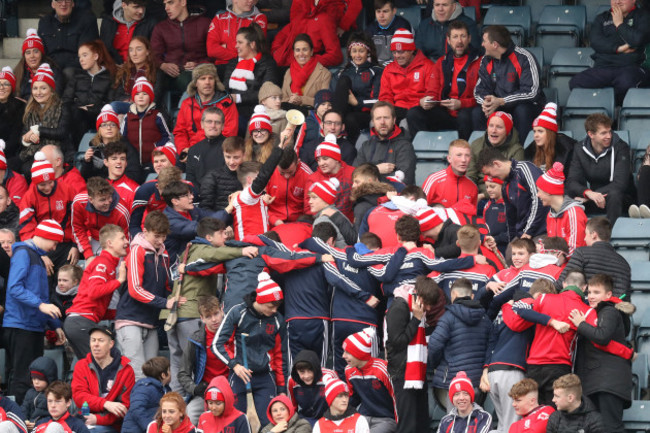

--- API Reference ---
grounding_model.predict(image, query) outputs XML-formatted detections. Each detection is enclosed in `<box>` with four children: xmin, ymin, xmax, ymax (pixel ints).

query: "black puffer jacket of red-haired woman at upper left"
<box><xmin>63</xmin><ymin>69</ymin><xmax>113</xmax><ymax>118</ymax></box>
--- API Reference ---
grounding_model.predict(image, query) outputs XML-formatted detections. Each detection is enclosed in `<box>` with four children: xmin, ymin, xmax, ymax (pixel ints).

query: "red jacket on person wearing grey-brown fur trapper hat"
<box><xmin>174</xmin><ymin>95</ymin><xmax>239</xmax><ymax>153</ymax></box>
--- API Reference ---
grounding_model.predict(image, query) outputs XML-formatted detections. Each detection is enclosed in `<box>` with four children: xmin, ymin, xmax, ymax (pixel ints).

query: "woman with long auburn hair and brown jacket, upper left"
<box><xmin>111</xmin><ymin>36</ymin><xmax>165</xmax><ymax>109</ymax></box>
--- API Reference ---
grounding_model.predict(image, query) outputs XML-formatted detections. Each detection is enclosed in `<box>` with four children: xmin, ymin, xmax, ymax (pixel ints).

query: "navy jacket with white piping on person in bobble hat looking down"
<box><xmin>210</xmin><ymin>292</ymin><xmax>288</xmax><ymax>394</ymax></box>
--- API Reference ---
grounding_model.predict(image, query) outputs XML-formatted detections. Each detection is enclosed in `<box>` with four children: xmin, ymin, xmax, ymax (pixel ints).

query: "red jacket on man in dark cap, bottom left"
<box><xmin>72</xmin><ymin>348</ymin><xmax>135</xmax><ymax>431</ymax></box>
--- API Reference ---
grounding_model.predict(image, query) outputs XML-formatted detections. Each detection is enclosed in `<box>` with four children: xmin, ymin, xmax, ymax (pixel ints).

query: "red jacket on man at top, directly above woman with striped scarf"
<box><xmin>207</xmin><ymin>7</ymin><xmax>268</xmax><ymax>64</ymax></box>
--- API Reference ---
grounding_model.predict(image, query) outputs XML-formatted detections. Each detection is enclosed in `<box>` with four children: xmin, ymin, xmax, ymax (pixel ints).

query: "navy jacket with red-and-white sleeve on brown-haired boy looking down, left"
<box><xmin>115</xmin><ymin>233</ymin><xmax>171</xmax><ymax>328</ymax></box>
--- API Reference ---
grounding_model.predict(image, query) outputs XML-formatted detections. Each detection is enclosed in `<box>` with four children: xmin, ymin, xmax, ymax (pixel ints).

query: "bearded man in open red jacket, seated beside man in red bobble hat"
<box><xmin>406</xmin><ymin>20</ymin><xmax>480</xmax><ymax>140</ymax></box>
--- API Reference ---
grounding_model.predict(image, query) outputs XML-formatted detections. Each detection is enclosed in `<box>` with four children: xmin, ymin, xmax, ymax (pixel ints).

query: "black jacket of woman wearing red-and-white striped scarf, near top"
<box><xmin>223</xmin><ymin>54</ymin><xmax>281</xmax><ymax>118</ymax></box>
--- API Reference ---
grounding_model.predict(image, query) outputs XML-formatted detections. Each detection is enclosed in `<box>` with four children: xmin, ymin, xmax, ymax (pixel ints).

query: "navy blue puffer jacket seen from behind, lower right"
<box><xmin>428</xmin><ymin>298</ymin><xmax>492</xmax><ymax>389</ymax></box>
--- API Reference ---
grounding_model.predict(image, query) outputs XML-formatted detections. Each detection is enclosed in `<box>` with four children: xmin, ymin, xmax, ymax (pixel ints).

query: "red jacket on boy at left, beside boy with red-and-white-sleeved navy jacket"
<box><xmin>66</xmin><ymin>250</ymin><xmax>120</xmax><ymax>323</ymax></box>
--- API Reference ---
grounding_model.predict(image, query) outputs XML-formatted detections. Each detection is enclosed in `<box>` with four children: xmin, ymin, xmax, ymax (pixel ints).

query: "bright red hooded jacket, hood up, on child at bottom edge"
<box><xmin>197</xmin><ymin>376</ymin><xmax>251</xmax><ymax>433</ymax></box>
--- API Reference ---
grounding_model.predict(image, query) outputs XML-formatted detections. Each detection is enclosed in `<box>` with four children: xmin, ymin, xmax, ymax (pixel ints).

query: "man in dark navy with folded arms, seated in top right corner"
<box><xmin>569</xmin><ymin>0</ymin><xmax>650</xmax><ymax>105</ymax></box>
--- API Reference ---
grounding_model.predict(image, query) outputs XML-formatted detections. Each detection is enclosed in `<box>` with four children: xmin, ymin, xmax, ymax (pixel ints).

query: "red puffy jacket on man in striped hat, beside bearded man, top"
<box><xmin>379</xmin><ymin>51</ymin><xmax>436</xmax><ymax>109</ymax></box>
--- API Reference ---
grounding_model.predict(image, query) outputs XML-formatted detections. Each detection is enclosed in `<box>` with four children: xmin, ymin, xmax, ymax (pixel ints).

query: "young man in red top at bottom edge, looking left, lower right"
<box><xmin>508</xmin><ymin>378</ymin><xmax>555</xmax><ymax>433</ymax></box>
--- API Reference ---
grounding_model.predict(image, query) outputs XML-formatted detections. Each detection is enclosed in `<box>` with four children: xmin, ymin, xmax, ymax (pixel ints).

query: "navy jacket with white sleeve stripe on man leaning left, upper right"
<box><xmin>474</xmin><ymin>44</ymin><xmax>546</xmax><ymax>109</ymax></box>
